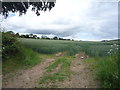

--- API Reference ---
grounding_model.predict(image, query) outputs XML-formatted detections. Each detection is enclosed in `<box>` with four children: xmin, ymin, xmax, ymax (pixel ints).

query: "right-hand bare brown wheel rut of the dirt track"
<box><xmin>59</xmin><ymin>53</ymin><xmax>99</xmax><ymax>88</ymax></box>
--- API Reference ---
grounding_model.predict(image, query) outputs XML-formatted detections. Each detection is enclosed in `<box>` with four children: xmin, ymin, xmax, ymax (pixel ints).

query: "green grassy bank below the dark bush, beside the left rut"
<box><xmin>2</xmin><ymin>47</ymin><xmax>42</xmax><ymax>74</ymax></box>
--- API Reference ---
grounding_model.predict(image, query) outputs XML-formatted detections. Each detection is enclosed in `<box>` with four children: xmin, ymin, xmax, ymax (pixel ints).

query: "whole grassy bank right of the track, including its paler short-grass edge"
<box><xmin>84</xmin><ymin>55</ymin><xmax>120</xmax><ymax>88</ymax></box>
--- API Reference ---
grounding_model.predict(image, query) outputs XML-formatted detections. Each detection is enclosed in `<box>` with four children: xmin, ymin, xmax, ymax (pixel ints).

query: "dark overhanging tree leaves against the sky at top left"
<box><xmin>0</xmin><ymin>0</ymin><xmax>56</xmax><ymax>18</ymax></box>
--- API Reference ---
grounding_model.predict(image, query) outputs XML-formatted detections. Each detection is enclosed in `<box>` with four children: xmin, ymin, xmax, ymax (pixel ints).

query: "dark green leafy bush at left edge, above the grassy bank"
<box><xmin>2</xmin><ymin>31</ymin><xmax>23</xmax><ymax>61</ymax></box>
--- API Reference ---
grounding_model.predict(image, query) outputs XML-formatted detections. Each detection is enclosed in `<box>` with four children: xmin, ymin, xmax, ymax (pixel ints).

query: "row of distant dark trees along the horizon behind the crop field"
<box><xmin>3</xmin><ymin>31</ymin><xmax>74</xmax><ymax>41</ymax></box>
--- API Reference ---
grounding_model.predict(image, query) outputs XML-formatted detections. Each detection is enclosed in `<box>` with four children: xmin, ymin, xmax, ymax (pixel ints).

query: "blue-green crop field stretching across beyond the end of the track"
<box><xmin>20</xmin><ymin>39</ymin><xmax>118</xmax><ymax>57</ymax></box>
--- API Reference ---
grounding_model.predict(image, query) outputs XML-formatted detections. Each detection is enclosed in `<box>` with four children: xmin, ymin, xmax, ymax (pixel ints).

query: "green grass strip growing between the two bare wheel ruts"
<box><xmin>39</xmin><ymin>56</ymin><xmax>73</xmax><ymax>87</ymax></box>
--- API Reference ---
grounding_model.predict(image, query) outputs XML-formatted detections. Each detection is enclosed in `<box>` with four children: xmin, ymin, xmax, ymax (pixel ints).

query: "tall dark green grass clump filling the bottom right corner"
<box><xmin>97</xmin><ymin>55</ymin><xmax>120</xmax><ymax>88</ymax></box>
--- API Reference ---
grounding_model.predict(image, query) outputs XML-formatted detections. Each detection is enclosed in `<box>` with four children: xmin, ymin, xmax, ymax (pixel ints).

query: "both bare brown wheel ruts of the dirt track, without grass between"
<box><xmin>3</xmin><ymin>53</ymin><xmax>99</xmax><ymax>88</ymax></box>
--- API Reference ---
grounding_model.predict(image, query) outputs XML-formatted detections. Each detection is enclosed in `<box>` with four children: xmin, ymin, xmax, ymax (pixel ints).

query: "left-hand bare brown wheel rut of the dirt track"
<box><xmin>3</xmin><ymin>59</ymin><xmax>54</xmax><ymax>88</ymax></box>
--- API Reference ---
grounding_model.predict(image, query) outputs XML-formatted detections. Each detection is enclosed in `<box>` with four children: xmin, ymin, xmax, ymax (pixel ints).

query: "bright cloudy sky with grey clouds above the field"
<box><xmin>2</xmin><ymin>0</ymin><xmax>118</xmax><ymax>41</ymax></box>
